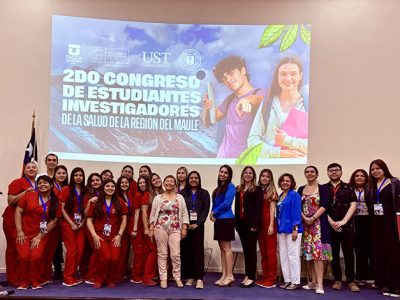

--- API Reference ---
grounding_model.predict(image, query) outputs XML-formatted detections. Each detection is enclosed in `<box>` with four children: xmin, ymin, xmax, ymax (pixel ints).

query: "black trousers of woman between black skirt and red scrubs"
<box><xmin>236</xmin><ymin>219</ymin><xmax>258</xmax><ymax>280</ymax></box>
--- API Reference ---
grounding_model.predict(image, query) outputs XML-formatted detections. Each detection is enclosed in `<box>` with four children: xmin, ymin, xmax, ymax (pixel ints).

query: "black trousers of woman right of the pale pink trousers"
<box><xmin>181</xmin><ymin>225</ymin><xmax>204</xmax><ymax>280</ymax></box>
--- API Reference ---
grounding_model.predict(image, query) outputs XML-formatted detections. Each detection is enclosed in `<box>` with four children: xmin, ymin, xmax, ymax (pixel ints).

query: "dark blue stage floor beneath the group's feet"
<box><xmin>0</xmin><ymin>273</ymin><xmax>382</xmax><ymax>300</ymax></box>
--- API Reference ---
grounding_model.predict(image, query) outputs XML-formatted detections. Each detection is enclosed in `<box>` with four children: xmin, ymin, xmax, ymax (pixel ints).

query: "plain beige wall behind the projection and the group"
<box><xmin>0</xmin><ymin>0</ymin><xmax>400</xmax><ymax>267</ymax></box>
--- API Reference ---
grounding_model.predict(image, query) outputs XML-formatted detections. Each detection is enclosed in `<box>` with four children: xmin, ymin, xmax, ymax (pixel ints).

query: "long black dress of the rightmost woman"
<box><xmin>367</xmin><ymin>182</ymin><xmax>400</xmax><ymax>290</ymax></box>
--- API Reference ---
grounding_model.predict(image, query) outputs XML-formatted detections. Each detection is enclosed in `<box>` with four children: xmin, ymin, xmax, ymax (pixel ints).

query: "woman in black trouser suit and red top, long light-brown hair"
<box><xmin>235</xmin><ymin>166</ymin><xmax>263</xmax><ymax>288</ymax></box>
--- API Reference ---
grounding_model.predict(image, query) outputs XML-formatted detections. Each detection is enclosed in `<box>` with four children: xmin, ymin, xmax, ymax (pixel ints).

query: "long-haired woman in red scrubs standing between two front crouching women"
<box><xmin>59</xmin><ymin>167</ymin><xmax>86</xmax><ymax>287</ymax></box>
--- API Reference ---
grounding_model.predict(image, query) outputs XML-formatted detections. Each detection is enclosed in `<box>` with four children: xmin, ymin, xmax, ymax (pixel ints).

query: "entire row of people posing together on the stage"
<box><xmin>3</xmin><ymin>154</ymin><xmax>400</xmax><ymax>296</ymax></box>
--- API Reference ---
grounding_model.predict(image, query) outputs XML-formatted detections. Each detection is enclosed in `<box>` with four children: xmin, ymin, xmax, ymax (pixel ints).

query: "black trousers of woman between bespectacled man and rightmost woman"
<box><xmin>354</xmin><ymin>216</ymin><xmax>374</xmax><ymax>280</ymax></box>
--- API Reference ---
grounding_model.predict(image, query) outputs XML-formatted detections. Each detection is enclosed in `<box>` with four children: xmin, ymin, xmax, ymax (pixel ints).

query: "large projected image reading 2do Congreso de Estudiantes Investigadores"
<box><xmin>49</xmin><ymin>16</ymin><xmax>311</xmax><ymax>164</ymax></box>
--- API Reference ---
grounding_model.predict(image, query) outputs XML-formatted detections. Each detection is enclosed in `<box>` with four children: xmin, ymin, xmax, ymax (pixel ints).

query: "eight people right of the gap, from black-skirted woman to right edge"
<box><xmin>210</xmin><ymin>159</ymin><xmax>400</xmax><ymax>297</ymax></box>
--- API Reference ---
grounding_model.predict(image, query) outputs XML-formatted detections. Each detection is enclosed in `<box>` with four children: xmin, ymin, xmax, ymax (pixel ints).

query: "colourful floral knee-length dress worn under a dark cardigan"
<box><xmin>301</xmin><ymin>193</ymin><xmax>332</xmax><ymax>261</ymax></box>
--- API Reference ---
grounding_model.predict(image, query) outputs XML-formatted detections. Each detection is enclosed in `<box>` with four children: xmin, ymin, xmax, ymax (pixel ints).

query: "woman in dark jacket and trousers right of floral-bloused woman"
<box><xmin>181</xmin><ymin>171</ymin><xmax>210</xmax><ymax>289</ymax></box>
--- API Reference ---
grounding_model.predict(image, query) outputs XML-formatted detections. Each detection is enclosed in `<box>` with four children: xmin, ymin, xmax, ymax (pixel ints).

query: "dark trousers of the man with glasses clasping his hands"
<box><xmin>331</xmin><ymin>227</ymin><xmax>354</xmax><ymax>282</ymax></box>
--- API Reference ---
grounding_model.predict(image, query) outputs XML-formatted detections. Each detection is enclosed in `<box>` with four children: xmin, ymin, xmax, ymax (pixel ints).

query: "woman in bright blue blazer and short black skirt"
<box><xmin>210</xmin><ymin>165</ymin><xmax>236</xmax><ymax>287</ymax></box>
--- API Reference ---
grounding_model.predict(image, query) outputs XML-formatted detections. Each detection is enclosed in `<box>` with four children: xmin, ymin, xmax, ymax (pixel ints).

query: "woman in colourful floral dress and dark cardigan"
<box><xmin>298</xmin><ymin>166</ymin><xmax>332</xmax><ymax>294</ymax></box>
